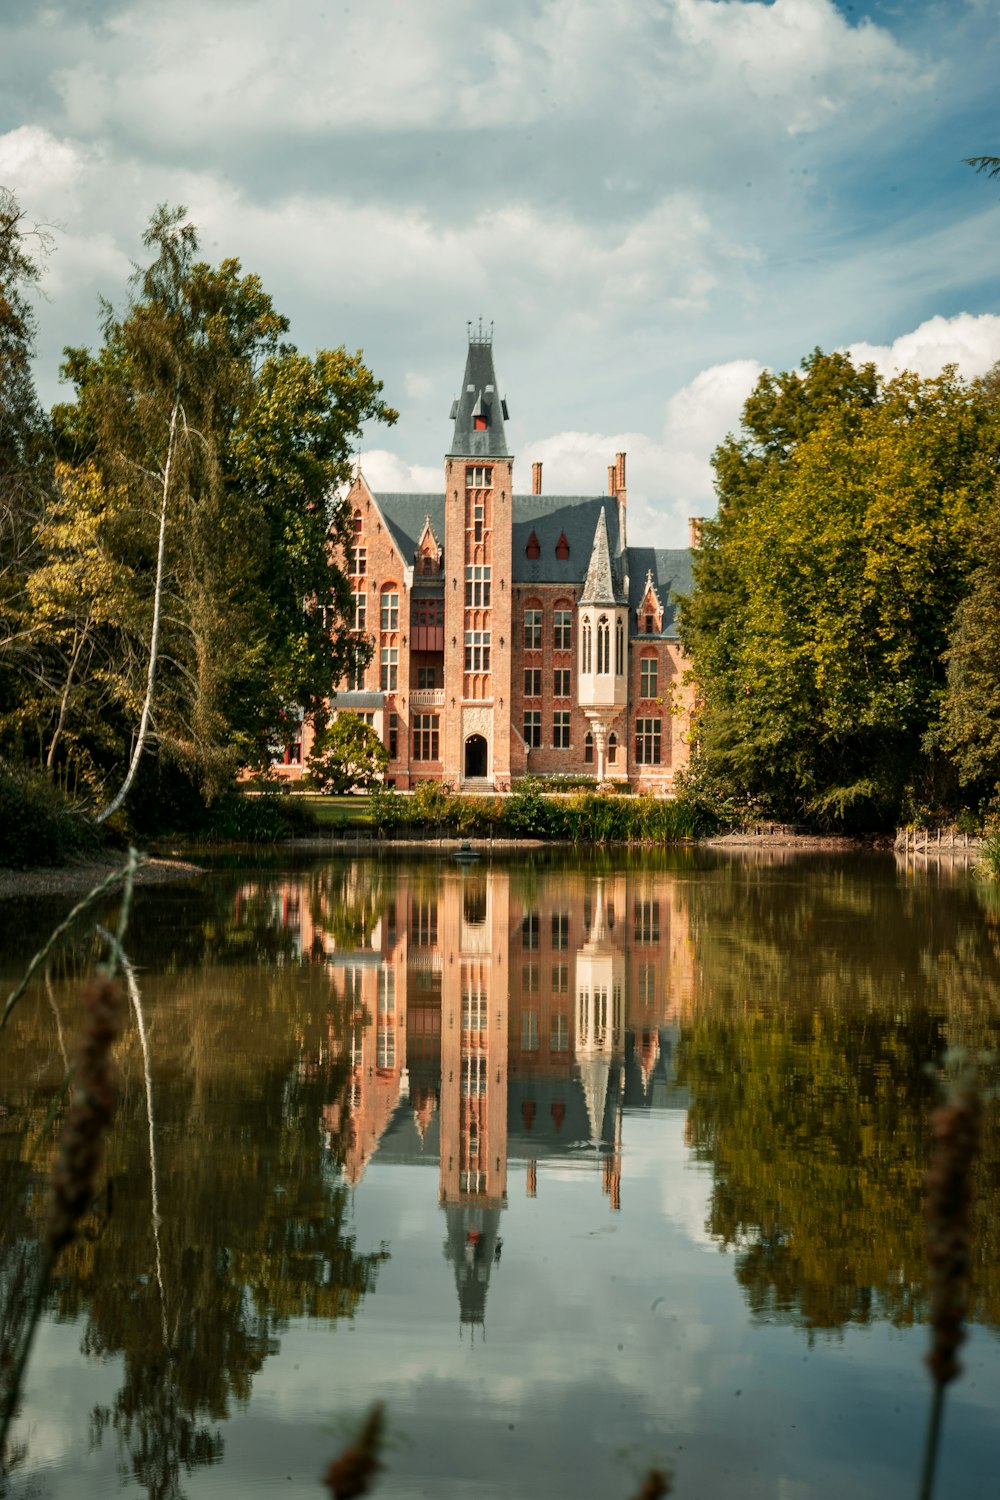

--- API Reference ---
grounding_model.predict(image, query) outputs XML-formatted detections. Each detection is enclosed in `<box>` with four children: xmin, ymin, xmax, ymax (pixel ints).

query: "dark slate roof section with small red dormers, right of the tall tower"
<box><xmin>511</xmin><ymin>495</ymin><xmax>621</xmax><ymax>585</ymax></box>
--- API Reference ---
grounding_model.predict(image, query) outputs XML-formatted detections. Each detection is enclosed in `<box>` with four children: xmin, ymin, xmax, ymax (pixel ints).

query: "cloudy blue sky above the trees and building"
<box><xmin>0</xmin><ymin>0</ymin><xmax>1000</xmax><ymax>546</ymax></box>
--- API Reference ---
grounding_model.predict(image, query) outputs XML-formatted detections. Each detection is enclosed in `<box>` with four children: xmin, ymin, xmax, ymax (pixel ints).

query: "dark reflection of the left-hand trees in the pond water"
<box><xmin>4</xmin><ymin>966</ymin><xmax>385</xmax><ymax>1500</ymax></box>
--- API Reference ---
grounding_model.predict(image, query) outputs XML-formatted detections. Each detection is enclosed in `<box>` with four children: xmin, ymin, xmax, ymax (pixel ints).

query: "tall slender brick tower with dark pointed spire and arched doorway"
<box><xmin>441</xmin><ymin>323</ymin><xmax>514</xmax><ymax>791</ymax></box>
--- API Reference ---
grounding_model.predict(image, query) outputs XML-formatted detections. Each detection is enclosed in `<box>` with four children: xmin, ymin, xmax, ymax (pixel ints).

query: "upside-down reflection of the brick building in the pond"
<box><xmin>254</xmin><ymin>861</ymin><xmax>693</xmax><ymax>1328</ymax></box>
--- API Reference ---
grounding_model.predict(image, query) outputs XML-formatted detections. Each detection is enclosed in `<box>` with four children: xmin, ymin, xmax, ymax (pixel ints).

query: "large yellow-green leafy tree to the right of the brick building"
<box><xmin>682</xmin><ymin>351</ymin><xmax>996</xmax><ymax>828</ymax></box>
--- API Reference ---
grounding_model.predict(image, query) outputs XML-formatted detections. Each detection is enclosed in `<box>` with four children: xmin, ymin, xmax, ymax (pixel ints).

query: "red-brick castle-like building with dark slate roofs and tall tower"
<box><xmin>277</xmin><ymin>332</ymin><xmax>691</xmax><ymax>794</ymax></box>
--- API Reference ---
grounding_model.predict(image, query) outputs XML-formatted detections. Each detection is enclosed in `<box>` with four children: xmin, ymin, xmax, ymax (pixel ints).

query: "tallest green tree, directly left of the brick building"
<box><xmin>54</xmin><ymin>207</ymin><xmax>396</xmax><ymax>816</ymax></box>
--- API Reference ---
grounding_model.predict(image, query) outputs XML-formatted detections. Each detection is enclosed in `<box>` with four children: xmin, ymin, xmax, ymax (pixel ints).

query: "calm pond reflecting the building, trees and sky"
<box><xmin>0</xmin><ymin>851</ymin><xmax>1000</xmax><ymax>1500</ymax></box>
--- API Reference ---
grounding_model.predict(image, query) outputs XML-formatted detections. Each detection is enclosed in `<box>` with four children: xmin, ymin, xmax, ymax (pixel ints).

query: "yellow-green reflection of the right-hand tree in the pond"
<box><xmin>678</xmin><ymin>866</ymin><xmax>1000</xmax><ymax>1329</ymax></box>
